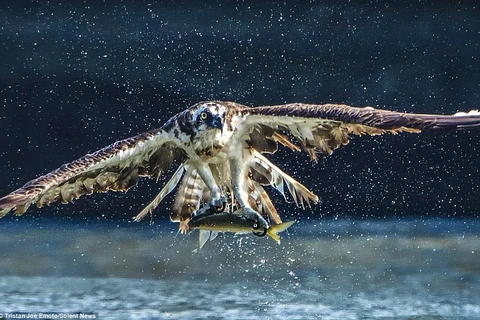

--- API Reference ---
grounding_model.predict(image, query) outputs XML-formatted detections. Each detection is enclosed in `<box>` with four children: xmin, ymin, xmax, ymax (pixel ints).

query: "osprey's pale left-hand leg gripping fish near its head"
<box><xmin>194</xmin><ymin>162</ymin><xmax>227</xmax><ymax>215</ymax></box>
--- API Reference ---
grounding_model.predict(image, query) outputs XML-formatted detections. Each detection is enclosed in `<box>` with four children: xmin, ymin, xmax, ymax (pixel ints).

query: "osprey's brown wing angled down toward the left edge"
<box><xmin>0</xmin><ymin>127</ymin><xmax>185</xmax><ymax>217</ymax></box>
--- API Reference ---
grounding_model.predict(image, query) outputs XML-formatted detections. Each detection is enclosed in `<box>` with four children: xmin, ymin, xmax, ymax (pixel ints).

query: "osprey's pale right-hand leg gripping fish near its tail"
<box><xmin>230</xmin><ymin>157</ymin><xmax>270</xmax><ymax>230</ymax></box>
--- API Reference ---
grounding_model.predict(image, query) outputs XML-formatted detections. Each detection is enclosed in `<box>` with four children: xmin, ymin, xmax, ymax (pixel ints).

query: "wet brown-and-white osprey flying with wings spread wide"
<box><xmin>0</xmin><ymin>101</ymin><xmax>480</xmax><ymax>232</ymax></box>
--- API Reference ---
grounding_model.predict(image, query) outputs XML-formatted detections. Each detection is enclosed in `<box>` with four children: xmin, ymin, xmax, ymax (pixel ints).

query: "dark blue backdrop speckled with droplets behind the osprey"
<box><xmin>0</xmin><ymin>1</ymin><xmax>480</xmax><ymax>221</ymax></box>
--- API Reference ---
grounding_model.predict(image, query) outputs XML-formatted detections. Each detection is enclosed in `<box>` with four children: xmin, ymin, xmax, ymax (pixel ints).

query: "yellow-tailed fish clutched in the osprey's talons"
<box><xmin>188</xmin><ymin>209</ymin><xmax>295</xmax><ymax>248</ymax></box>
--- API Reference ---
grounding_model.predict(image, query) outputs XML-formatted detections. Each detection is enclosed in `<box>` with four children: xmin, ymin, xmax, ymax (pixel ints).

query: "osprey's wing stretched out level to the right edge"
<box><xmin>229</xmin><ymin>103</ymin><xmax>480</xmax><ymax>160</ymax></box>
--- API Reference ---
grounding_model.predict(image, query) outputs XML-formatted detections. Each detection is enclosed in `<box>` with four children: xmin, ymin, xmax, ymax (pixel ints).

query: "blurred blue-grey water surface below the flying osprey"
<box><xmin>0</xmin><ymin>219</ymin><xmax>480</xmax><ymax>319</ymax></box>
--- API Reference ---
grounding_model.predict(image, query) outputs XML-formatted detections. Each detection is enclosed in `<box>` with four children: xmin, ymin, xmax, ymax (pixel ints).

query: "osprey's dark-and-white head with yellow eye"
<box><xmin>192</xmin><ymin>102</ymin><xmax>226</xmax><ymax>132</ymax></box>
